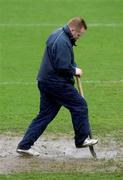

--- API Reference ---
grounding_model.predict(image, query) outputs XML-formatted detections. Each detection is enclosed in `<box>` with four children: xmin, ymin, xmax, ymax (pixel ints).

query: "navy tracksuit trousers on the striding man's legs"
<box><xmin>18</xmin><ymin>82</ymin><xmax>89</xmax><ymax>149</ymax></box>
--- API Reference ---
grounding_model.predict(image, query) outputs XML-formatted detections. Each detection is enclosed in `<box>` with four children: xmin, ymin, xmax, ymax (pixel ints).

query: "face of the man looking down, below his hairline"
<box><xmin>71</xmin><ymin>27</ymin><xmax>86</xmax><ymax>40</ymax></box>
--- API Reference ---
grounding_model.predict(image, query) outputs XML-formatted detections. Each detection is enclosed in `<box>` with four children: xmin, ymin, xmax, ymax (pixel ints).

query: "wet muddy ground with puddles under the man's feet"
<box><xmin>0</xmin><ymin>135</ymin><xmax>123</xmax><ymax>174</ymax></box>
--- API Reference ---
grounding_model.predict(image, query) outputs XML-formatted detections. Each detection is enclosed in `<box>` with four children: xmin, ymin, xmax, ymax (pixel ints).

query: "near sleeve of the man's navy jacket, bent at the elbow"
<box><xmin>53</xmin><ymin>40</ymin><xmax>75</xmax><ymax>76</ymax></box>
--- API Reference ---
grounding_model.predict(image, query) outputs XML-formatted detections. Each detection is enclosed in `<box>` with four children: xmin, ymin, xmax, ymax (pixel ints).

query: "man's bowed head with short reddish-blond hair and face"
<box><xmin>67</xmin><ymin>17</ymin><xmax>87</xmax><ymax>40</ymax></box>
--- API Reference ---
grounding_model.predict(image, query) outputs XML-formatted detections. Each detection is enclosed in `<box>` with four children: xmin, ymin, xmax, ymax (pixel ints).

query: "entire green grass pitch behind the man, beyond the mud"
<box><xmin>0</xmin><ymin>0</ymin><xmax>123</xmax><ymax>135</ymax></box>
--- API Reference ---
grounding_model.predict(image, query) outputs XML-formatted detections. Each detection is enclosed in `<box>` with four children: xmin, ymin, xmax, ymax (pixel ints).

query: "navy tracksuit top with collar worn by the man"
<box><xmin>37</xmin><ymin>25</ymin><xmax>76</xmax><ymax>84</ymax></box>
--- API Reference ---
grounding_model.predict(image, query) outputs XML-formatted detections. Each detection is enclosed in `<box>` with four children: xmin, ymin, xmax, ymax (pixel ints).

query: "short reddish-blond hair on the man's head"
<box><xmin>67</xmin><ymin>17</ymin><xmax>87</xmax><ymax>30</ymax></box>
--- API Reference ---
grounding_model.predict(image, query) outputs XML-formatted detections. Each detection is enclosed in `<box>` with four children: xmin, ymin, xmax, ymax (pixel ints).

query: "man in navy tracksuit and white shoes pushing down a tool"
<box><xmin>17</xmin><ymin>17</ymin><xmax>98</xmax><ymax>155</ymax></box>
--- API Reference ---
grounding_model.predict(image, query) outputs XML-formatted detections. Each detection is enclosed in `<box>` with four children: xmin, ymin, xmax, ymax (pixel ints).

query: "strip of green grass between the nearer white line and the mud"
<box><xmin>0</xmin><ymin>83</ymin><xmax>123</xmax><ymax>136</ymax></box>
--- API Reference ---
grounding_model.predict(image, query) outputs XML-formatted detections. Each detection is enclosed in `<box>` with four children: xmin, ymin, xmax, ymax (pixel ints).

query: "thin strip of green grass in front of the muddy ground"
<box><xmin>0</xmin><ymin>173</ymin><xmax>123</xmax><ymax>180</ymax></box>
